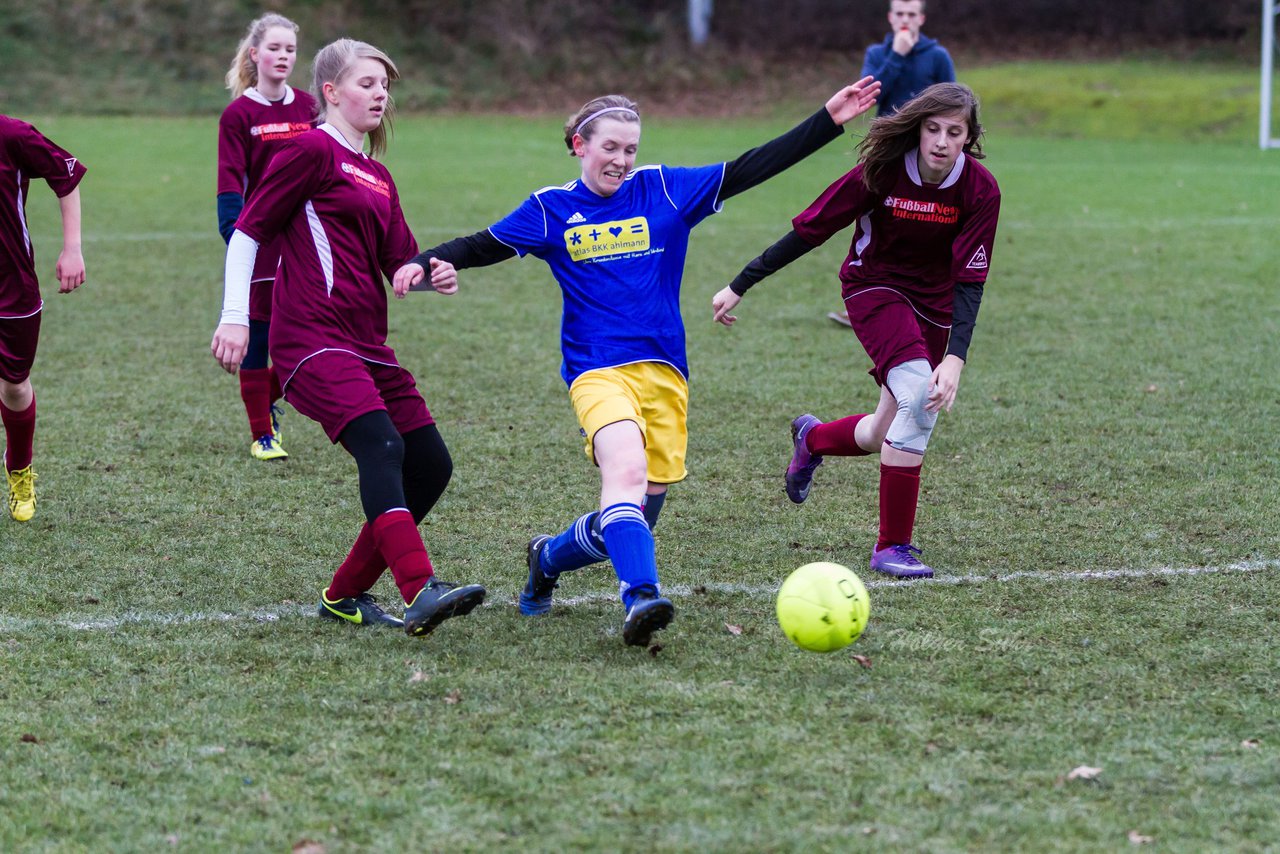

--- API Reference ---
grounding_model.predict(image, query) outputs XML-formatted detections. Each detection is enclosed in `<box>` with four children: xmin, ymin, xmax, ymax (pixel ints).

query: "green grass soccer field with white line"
<box><xmin>0</xmin><ymin>106</ymin><xmax>1280</xmax><ymax>853</ymax></box>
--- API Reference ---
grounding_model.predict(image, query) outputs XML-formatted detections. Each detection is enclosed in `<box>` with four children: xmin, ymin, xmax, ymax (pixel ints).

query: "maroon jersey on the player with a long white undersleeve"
<box><xmin>236</xmin><ymin>124</ymin><xmax>417</xmax><ymax>382</ymax></box>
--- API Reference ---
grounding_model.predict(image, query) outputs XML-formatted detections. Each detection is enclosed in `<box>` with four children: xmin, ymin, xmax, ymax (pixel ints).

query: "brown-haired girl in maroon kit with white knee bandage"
<box><xmin>712</xmin><ymin>83</ymin><xmax>1000</xmax><ymax>579</ymax></box>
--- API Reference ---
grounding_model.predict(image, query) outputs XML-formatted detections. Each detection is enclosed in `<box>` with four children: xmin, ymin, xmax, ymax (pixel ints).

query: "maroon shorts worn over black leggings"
<box><xmin>284</xmin><ymin>351</ymin><xmax>435</xmax><ymax>442</ymax></box>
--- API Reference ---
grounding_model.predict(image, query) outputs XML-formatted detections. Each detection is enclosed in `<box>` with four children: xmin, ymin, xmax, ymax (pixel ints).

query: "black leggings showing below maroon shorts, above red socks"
<box><xmin>338</xmin><ymin>410</ymin><xmax>453</xmax><ymax>524</ymax></box>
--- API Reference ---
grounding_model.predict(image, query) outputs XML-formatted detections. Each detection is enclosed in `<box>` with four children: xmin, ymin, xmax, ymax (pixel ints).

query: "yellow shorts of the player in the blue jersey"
<box><xmin>568</xmin><ymin>362</ymin><xmax>689</xmax><ymax>484</ymax></box>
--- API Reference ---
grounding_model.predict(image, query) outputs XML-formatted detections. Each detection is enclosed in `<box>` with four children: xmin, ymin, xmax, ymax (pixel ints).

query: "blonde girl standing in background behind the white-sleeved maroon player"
<box><xmin>218</xmin><ymin>13</ymin><xmax>316</xmax><ymax>460</ymax></box>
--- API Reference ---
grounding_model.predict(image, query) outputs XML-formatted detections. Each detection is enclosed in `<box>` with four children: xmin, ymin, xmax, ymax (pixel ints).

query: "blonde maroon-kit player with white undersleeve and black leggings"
<box><xmin>211</xmin><ymin>38</ymin><xmax>485</xmax><ymax>635</ymax></box>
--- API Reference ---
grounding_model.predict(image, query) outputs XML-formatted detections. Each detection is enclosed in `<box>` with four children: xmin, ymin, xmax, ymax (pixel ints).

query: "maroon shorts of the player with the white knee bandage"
<box><xmin>845</xmin><ymin>288</ymin><xmax>951</xmax><ymax>385</ymax></box>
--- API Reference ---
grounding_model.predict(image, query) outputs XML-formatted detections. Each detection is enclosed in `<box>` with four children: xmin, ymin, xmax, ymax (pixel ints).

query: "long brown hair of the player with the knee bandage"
<box><xmin>858</xmin><ymin>83</ymin><xmax>986</xmax><ymax>193</ymax></box>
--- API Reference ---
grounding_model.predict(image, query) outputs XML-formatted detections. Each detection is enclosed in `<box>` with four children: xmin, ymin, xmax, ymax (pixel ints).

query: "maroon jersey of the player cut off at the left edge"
<box><xmin>0</xmin><ymin>115</ymin><xmax>84</xmax><ymax>318</ymax></box>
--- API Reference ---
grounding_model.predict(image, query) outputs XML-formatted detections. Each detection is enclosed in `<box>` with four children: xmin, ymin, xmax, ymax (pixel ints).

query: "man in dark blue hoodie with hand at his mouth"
<box><xmin>861</xmin><ymin>0</ymin><xmax>956</xmax><ymax>115</ymax></box>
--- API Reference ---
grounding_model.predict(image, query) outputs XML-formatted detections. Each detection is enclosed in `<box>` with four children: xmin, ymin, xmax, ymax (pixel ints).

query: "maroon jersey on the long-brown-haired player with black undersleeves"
<box><xmin>791</xmin><ymin>149</ymin><xmax>1000</xmax><ymax>325</ymax></box>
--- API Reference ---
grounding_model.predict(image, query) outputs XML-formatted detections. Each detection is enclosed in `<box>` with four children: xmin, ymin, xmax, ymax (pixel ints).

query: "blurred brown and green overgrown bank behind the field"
<box><xmin>0</xmin><ymin>0</ymin><xmax>1261</xmax><ymax>113</ymax></box>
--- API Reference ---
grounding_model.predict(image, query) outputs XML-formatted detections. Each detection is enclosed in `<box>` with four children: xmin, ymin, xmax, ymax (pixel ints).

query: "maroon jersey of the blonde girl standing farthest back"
<box><xmin>218</xmin><ymin>86</ymin><xmax>316</xmax><ymax>282</ymax></box>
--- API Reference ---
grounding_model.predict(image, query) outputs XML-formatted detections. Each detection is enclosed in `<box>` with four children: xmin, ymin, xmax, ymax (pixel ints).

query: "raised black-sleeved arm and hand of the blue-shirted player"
<box><xmin>717</xmin><ymin>77</ymin><xmax>881</xmax><ymax>202</ymax></box>
